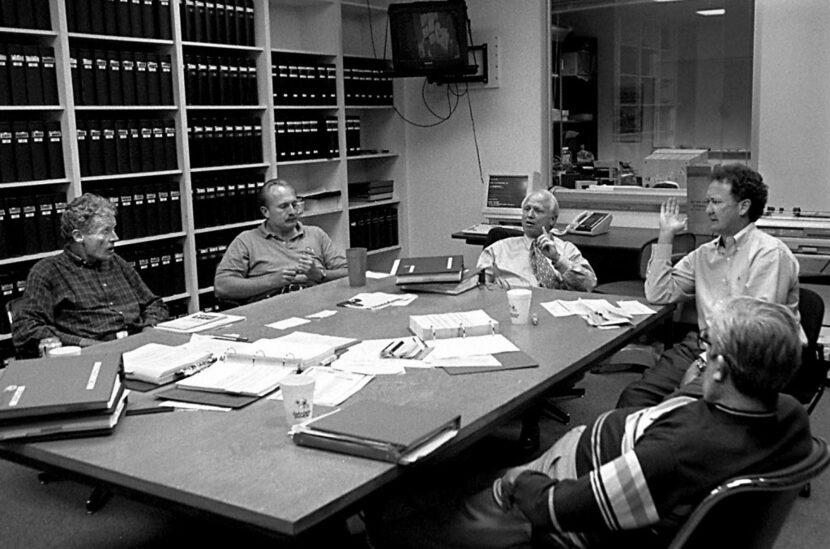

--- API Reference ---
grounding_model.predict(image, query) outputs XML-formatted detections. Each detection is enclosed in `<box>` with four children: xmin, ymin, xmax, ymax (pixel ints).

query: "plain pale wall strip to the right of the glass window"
<box><xmin>752</xmin><ymin>0</ymin><xmax>830</xmax><ymax>211</ymax></box>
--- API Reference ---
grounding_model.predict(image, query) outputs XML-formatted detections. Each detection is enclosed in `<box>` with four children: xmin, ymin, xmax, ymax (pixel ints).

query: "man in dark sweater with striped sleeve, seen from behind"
<box><xmin>370</xmin><ymin>297</ymin><xmax>811</xmax><ymax>548</ymax></box>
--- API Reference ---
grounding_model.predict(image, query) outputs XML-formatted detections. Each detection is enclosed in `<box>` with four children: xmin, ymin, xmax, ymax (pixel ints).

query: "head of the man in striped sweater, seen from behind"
<box><xmin>709</xmin><ymin>297</ymin><xmax>801</xmax><ymax>401</ymax></box>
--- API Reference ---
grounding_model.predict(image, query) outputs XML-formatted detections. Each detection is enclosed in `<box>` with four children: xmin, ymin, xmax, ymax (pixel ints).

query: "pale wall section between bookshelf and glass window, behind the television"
<box><xmin>405</xmin><ymin>0</ymin><xmax>548</xmax><ymax>266</ymax></box>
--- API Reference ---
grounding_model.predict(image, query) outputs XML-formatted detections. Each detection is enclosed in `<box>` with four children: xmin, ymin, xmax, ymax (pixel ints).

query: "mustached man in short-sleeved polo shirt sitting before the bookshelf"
<box><xmin>213</xmin><ymin>179</ymin><xmax>348</xmax><ymax>302</ymax></box>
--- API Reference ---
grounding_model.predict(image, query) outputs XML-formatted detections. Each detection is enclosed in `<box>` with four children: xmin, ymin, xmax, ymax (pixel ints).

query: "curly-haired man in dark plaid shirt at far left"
<box><xmin>12</xmin><ymin>193</ymin><xmax>168</xmax><ymax>356</ymax></box>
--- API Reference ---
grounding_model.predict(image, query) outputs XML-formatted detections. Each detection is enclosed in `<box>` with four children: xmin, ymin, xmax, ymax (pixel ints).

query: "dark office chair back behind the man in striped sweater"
<box><xmin>669</xmin><ymin>437</ymin><xmax>830</xmax><ymax>549</ymax></box>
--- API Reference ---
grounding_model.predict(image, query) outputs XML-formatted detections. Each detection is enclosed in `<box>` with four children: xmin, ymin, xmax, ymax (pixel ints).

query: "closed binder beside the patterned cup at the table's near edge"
<box><xmin>291</xmin><ymin>400</ymin><xmax>461</xmax><ymax>463</ymax></box>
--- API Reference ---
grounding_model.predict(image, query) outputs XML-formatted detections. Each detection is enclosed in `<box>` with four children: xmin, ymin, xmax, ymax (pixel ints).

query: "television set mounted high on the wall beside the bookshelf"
<box><xmin>388</xmin><ymin>0</ymin><xmax>475</xmax><ymax>76</ymax></box>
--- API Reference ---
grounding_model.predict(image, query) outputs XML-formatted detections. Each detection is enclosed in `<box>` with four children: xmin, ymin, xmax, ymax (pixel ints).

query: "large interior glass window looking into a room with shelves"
<box><xmin>551</xmin><ymin>0</ymin><xmax>754</xmax><ymax>180</ymax></box>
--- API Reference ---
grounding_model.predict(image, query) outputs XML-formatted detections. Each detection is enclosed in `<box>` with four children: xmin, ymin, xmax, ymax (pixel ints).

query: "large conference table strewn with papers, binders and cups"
<box><xmin>0</xmin><ymin>278</ymin><xmax>671</xmax><ymax>540</ymax></box>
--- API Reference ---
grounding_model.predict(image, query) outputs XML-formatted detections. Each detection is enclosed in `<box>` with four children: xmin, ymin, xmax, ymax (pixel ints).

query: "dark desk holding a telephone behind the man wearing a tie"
<box><xmin>452</xmin><ymin>226</ymin><xmax>657</xmax><ymax>284</ymax></box>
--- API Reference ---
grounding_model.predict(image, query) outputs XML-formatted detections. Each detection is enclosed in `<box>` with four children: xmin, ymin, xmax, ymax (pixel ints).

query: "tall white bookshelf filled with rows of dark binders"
<box><xmin>0</xmin><ymin>0</ymin><xmax>406</xmax><ymax>342</ymax></box>
